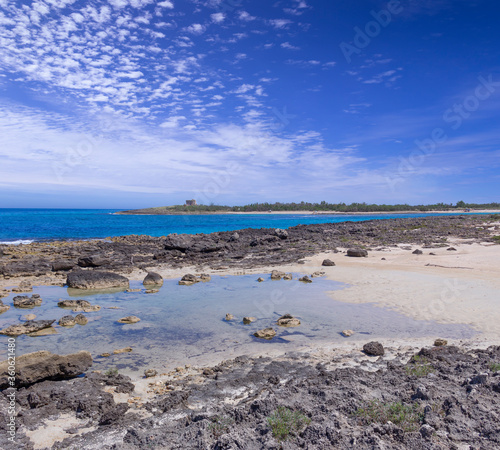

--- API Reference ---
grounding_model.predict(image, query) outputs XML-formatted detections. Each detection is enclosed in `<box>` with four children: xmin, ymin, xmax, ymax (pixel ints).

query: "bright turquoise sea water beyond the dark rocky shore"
<box><xmin>0</xmin><ymin>209</ymin><xmax>484</xmax><ymax>243</ymax></box>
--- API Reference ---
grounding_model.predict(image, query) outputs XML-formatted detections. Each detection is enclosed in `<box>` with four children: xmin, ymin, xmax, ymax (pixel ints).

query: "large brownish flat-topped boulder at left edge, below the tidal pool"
<box><xmin>0</xmin><ymin>351</ymin><xmax>92</xmax><ymax>389</ymax></box>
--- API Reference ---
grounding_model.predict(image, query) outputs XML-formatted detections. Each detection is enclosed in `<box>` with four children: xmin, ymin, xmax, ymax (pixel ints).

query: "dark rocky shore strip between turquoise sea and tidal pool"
<box><xmin>0</xmin><ymin>215</ymin><xmax>500</xmax><ymax>280</ymax></box>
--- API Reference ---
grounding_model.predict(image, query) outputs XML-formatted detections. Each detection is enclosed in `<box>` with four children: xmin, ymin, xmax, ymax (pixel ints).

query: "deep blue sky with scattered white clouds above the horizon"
<box><xmin>0</xmin><ymin>0</ymin><xmax>500</xmax><ymax>208</ymax></box>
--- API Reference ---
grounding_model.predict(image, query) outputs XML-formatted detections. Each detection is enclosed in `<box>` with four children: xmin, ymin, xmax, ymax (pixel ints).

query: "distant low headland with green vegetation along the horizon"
<box><xmin>118</xmin><ymin>201</ymin><xmax>500</xmax><ymax>215</ymax></box>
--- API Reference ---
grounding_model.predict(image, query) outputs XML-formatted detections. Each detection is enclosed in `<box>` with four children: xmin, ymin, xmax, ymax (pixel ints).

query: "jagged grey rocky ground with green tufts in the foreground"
<box><xmin>0</xmin><ymin>343</ymin><xmax>500</xmax><ymax>450</ymax></box>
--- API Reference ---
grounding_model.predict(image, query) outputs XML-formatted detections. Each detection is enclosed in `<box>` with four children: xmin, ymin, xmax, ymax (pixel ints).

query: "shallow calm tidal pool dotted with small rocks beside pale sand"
<box><xmin>0</xmin><ymin>274</ymin><xmax>477</xmax><ymax>376</ymax></box>
